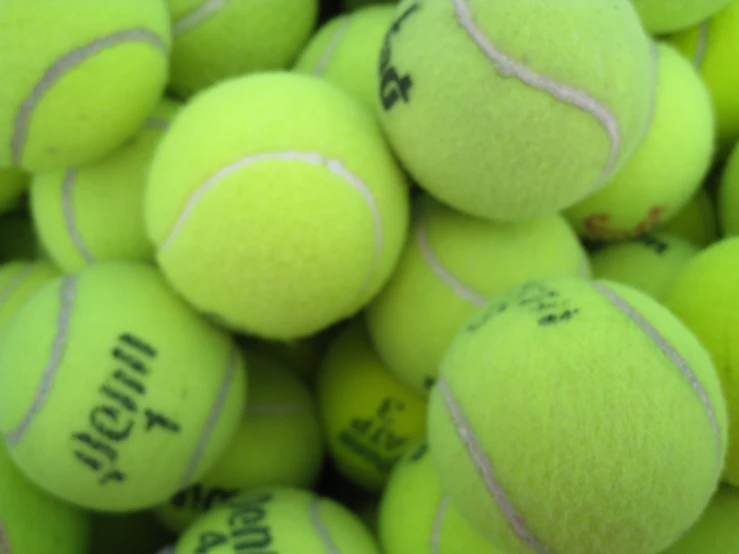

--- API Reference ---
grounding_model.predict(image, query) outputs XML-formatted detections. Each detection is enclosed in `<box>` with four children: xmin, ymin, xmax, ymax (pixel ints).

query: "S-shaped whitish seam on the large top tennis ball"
<box><xmin>452</xmin><ymin>0</ymin><xmax>621</xmax><ymax>188</ymax></box>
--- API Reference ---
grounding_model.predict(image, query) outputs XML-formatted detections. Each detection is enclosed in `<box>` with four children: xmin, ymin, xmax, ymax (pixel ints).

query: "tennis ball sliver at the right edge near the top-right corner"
<box><xmin>666</xmin><ymin>0</ymin><xmax>739</xmax><ymax>150</ymax></box>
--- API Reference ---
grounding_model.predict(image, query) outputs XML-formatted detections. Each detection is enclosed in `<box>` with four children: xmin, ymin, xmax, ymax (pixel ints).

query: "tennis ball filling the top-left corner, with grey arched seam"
<box><xmin>0</xmin><ymin>0</ymin><xmax>170</xmax><ymax>171</ymax></box>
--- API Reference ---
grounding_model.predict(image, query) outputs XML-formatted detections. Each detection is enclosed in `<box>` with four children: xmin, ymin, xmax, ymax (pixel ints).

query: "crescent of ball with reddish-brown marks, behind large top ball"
<box><xmin>565</xmin><ymin>44</ymin><xmax>714</xmax><ymax>240</ymax></box>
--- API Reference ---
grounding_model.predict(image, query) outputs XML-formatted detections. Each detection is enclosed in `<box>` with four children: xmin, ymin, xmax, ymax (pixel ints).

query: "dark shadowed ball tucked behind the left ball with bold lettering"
<box><xmin>157</xmin><ymin>352</ymin><xmax>323</xmax><ymax>533</ymax></box>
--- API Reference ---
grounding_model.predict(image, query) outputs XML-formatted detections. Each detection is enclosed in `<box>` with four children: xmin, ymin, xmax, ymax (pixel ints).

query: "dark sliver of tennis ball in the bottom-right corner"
<box><xmin>662</xmin><ymin>485</ymin><xmax>739</xmax><ymax>554</ymax></box>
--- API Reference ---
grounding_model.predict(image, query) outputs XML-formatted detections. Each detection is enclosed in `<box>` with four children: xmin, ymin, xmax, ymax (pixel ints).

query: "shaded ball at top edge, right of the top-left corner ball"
<box><xmin>166</xmin><ymin>0</ymin><xmax>318</xmax><ymax>98</ymax></box>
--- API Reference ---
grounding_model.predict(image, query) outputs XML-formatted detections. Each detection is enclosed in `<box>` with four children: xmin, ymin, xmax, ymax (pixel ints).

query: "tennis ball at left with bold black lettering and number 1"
<box><xmin>0</xmin><ymin>262</ymin><xmax>246</xmax><ymax>512</ymax></box>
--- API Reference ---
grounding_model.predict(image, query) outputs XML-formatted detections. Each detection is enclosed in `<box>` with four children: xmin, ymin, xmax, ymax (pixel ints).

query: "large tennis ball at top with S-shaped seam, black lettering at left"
<box><xmin>378</xmin><ymin>0</ymin><xmax>655</xmax><ymax>221</ymax></box>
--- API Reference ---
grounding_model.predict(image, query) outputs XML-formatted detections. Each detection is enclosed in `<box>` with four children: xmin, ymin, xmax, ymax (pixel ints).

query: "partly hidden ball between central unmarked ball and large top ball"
<box><xmin>295</xmin><ymin>5</ymin><xmax>395</xmax><ymax>112</ymax></box>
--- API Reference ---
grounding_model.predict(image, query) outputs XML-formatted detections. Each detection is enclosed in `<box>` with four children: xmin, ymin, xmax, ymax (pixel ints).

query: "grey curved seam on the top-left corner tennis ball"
<box><xmin>11</xmin><ymin>29</ymin><xmax>169</xmax><ymax>165</ymax></box>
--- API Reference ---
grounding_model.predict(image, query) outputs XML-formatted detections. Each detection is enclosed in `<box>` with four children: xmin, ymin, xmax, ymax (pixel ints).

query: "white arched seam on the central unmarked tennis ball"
<box><xmin>159</xmin><ymin>152</ymin><xmax>385</xmax><ymax>293</ymax></box>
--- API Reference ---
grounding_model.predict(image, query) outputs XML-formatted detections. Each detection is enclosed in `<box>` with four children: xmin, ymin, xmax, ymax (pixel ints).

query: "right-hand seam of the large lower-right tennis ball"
<box><xmin>591</xmin><ymin>282</ymin><xmax>723</xmax><ymax>467</ymax></box>
